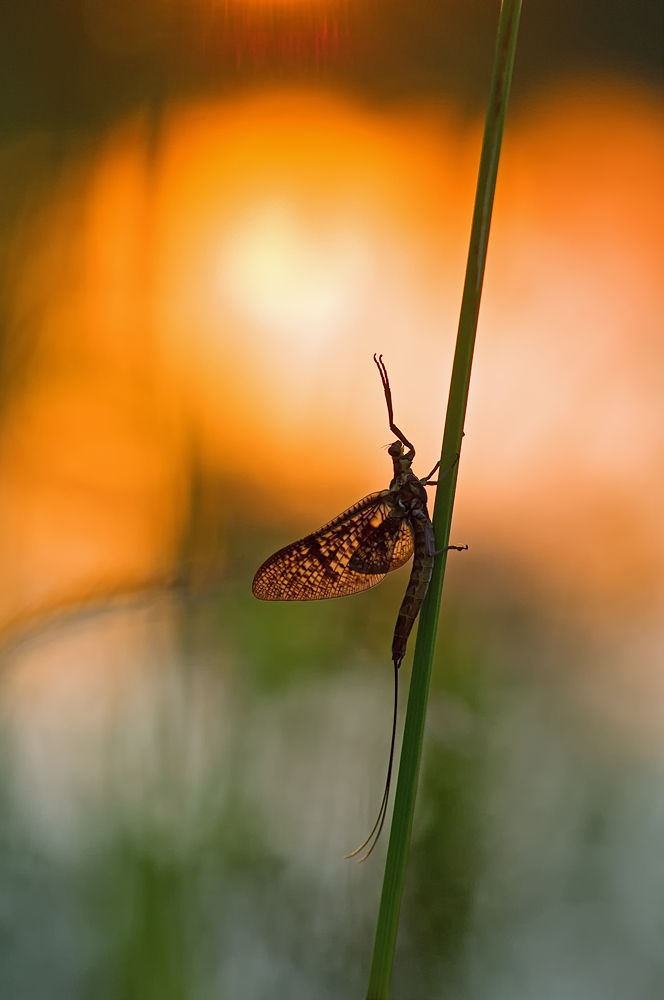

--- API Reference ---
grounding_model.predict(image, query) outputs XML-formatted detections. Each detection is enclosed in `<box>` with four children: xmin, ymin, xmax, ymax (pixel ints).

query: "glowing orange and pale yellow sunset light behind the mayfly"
<box><xmin>0</xmin><ymin>82</ymin><xmax>664</xmax><ymax>622</ymax></box>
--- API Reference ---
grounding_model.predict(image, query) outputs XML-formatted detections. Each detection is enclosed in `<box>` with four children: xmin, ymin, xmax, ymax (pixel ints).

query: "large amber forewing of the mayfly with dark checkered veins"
<box><xmin>252</xmin><ymin>490</ymin><xmax>400</xmax><ymax>601</ymax></box>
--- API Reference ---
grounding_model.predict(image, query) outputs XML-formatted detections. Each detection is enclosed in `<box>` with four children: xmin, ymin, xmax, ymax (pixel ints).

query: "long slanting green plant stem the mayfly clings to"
<box><xmin>366</xmin><ymin>0</ymin><xmax>521</xmax><ymax>1000</ymax></box>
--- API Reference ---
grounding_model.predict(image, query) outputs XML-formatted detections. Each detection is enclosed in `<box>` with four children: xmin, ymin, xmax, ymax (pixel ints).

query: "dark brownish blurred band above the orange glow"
<box><xmin>0</xmin><ymin>0</ymin><xmax>664</xmax><ymax>137</ymax></box>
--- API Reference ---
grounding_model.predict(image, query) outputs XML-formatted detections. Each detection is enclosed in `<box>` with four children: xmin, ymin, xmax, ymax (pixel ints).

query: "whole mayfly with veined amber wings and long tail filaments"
<box><xmin>252</xmin><ymin>354</ymin><xmax>467</xmax><ymax>861</ymax></box>
